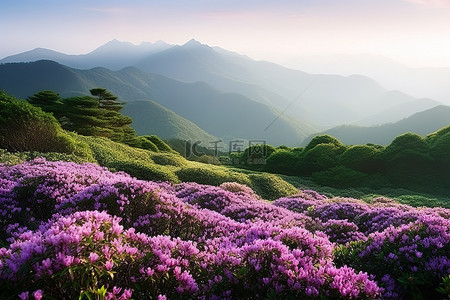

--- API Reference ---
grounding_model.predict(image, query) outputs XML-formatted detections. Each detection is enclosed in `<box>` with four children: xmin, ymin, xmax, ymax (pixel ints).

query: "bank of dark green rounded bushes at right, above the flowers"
<box><xmin>236</xmin><ymin>126</ymin><xmax>450</xmax><ymax>195</ymax></box>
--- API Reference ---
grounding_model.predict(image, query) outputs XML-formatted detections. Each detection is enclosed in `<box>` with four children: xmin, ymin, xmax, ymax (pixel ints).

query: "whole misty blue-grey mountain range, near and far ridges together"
<box><xmin>0</xmin><ymin>40</ymin><xmax>448</xmax><ymax>145</ymax></box>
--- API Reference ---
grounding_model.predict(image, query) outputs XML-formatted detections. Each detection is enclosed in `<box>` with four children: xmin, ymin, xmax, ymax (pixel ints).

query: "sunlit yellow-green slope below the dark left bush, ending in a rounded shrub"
<box><xmin>0</xmin><ymin>133</ymin><xmax>297</xmax><ymax>200</ymax></box>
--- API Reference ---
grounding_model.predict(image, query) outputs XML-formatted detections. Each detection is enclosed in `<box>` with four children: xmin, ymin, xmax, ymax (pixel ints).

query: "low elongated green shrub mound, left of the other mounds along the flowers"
<box><xmin>107</xmin><ymin>161</ymin><xmax>179</xmax><ymax>183</ymax></box>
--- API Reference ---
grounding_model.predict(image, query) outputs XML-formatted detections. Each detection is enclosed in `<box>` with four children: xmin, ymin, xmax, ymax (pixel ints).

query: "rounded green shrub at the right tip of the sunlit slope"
<box><xmin>249</xmin><ymin>173</ymin><xmax>298</xmax><ymax>200</ymax></box>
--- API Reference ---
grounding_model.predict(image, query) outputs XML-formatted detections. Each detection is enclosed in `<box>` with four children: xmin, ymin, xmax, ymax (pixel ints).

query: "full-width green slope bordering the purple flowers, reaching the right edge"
<box><xmin>0</xmin><ymin>126</ymin><xmax>450</xmax><ymax>208</ymax></box>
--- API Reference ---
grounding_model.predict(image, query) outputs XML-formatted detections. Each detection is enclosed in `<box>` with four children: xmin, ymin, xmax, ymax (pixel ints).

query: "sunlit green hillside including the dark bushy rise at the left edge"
<box><xmin>0</xmin><ymin>92</ymin><xmax>297</xmax><ymax>199</ymax></box>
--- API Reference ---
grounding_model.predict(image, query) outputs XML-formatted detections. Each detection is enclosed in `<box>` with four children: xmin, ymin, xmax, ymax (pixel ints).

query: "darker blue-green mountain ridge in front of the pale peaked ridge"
<box><xmin>0</xmin><ymin>61</ymin><xmax>317</xmax><ymax>145</ymax></box>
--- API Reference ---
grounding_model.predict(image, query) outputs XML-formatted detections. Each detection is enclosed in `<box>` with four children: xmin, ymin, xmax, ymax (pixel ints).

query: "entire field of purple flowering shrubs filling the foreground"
<box><xmin>0</xmin><ymin>159</ymin><xmax>450</xmax><ymax>299</ymax></box>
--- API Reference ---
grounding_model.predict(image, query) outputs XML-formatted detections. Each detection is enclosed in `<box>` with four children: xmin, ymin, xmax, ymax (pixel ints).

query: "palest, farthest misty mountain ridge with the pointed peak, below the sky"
<box><xmin>0</xmin><ymin>39</ymin><xmax>439</xmax><ymax>128</ymax></box>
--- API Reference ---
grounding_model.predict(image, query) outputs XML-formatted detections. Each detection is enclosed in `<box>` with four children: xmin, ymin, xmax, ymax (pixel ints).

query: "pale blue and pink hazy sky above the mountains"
<box><xmin>0</xmin><ymin>0</ymin><xmax>450</xmax><ymax>67</ymax></box>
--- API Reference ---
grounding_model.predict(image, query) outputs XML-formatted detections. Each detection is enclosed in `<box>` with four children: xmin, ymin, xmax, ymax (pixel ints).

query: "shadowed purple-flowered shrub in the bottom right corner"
<box><xmin>336</xmin><ymin>215</ymin><xmax>450</xmax><ymax>299</ymax></box>
